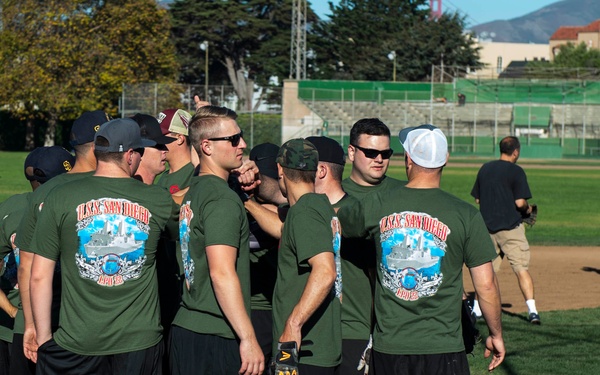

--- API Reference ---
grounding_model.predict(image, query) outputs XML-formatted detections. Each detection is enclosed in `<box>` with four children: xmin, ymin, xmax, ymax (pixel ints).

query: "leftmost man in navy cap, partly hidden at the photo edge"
<box><xmin>0</xmin><ymin>146</ymin><xmax>75</xmax><ymax>374</ymax></box>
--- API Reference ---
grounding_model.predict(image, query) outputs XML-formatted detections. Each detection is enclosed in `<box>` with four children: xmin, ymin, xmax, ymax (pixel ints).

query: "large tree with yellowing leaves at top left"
<box><xmin>0</xmin><ymin>0</ymin><xmax>177</xmax><ymax>147</ymax></box>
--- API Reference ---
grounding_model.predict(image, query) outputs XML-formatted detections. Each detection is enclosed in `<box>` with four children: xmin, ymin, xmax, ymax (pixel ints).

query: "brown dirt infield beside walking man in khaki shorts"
<box><xmin>463</xmin><ymin>246</ymin><xmax>600</xmax><ymax>313</ymax></box>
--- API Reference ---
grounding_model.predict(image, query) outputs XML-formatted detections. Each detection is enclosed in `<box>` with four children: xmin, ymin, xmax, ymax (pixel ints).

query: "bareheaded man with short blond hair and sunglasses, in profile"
<box><xmin>170</xmin><ymin>106</ymin><xmax>265</xmax><ymax>375</ymax></box>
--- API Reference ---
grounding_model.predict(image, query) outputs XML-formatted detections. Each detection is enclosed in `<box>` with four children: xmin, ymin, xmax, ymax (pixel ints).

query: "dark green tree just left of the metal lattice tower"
<box><xmin>170</xmin><ymin>0</ymin><xmax>317</xmax><ymax>110</ymax></box>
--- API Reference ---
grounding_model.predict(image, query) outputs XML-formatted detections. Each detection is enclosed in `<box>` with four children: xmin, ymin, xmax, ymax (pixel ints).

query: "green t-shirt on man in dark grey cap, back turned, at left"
<box><xmin>31</xmin><ymin>176</ymin><xmax>177</xmax><ymax>355</ymax></box>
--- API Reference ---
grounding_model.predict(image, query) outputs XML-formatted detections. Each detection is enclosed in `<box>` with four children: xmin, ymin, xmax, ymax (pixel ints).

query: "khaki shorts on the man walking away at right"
<box><xmin>490</xmin><ymin>224</ymin><xmax>531</xmax><ymax>272</ymax></box>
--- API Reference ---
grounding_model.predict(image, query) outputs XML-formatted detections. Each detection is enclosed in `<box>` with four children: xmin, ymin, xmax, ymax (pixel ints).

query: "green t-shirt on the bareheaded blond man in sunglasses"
<box><xmin>173</xmin><ymin>175</ymin><xmax>250</xmax><ymax>339</ymax></box>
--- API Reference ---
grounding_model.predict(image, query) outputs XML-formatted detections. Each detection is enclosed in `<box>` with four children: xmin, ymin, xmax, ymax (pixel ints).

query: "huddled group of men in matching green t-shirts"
<box><xmin>0</xmin><ymin>100</ymin><xmax>504</xmax><ymax>375</ymax></box>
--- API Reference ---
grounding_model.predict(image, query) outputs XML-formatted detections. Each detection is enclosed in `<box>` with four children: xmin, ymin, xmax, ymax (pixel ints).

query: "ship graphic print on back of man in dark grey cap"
<box><xmin>75</xmin><ymin>198</ymin><xmax>152</xmax><ymax>287</ymax></box>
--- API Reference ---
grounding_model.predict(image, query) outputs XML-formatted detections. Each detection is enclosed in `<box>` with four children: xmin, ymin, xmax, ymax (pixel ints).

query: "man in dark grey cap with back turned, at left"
<box><xmin>31</xmin><ymin>118</ymin><xmax>178</xmax><ymax>374</ymax></box>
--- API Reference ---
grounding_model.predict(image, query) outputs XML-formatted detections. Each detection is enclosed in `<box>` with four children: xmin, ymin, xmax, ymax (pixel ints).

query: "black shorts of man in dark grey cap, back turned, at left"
<box><xmin>36</xmin><ymin>339</ymin><xmax>163</xmax><ymax>375</ymax></box>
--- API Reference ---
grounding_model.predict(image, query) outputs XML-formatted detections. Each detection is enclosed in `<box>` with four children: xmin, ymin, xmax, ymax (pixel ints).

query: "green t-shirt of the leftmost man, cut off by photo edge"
<box><xmin>0</xmin><ymin>193</ymin><xmax>31</xmax><ymax>342</ymax></box>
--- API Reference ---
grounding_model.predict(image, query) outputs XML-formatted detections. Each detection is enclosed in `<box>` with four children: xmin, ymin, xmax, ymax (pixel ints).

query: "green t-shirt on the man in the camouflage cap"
<box><xmin>273</xmin><ymin>193</ymin><xmax>342</xmax><ymax>367</ymax></box>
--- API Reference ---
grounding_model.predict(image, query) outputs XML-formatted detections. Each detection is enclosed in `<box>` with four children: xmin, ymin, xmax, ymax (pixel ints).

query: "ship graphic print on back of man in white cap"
<box><xmin>379</xmin><ymin>211</ymin><xmax>450</xmax><ymax>301</ymax></box>
